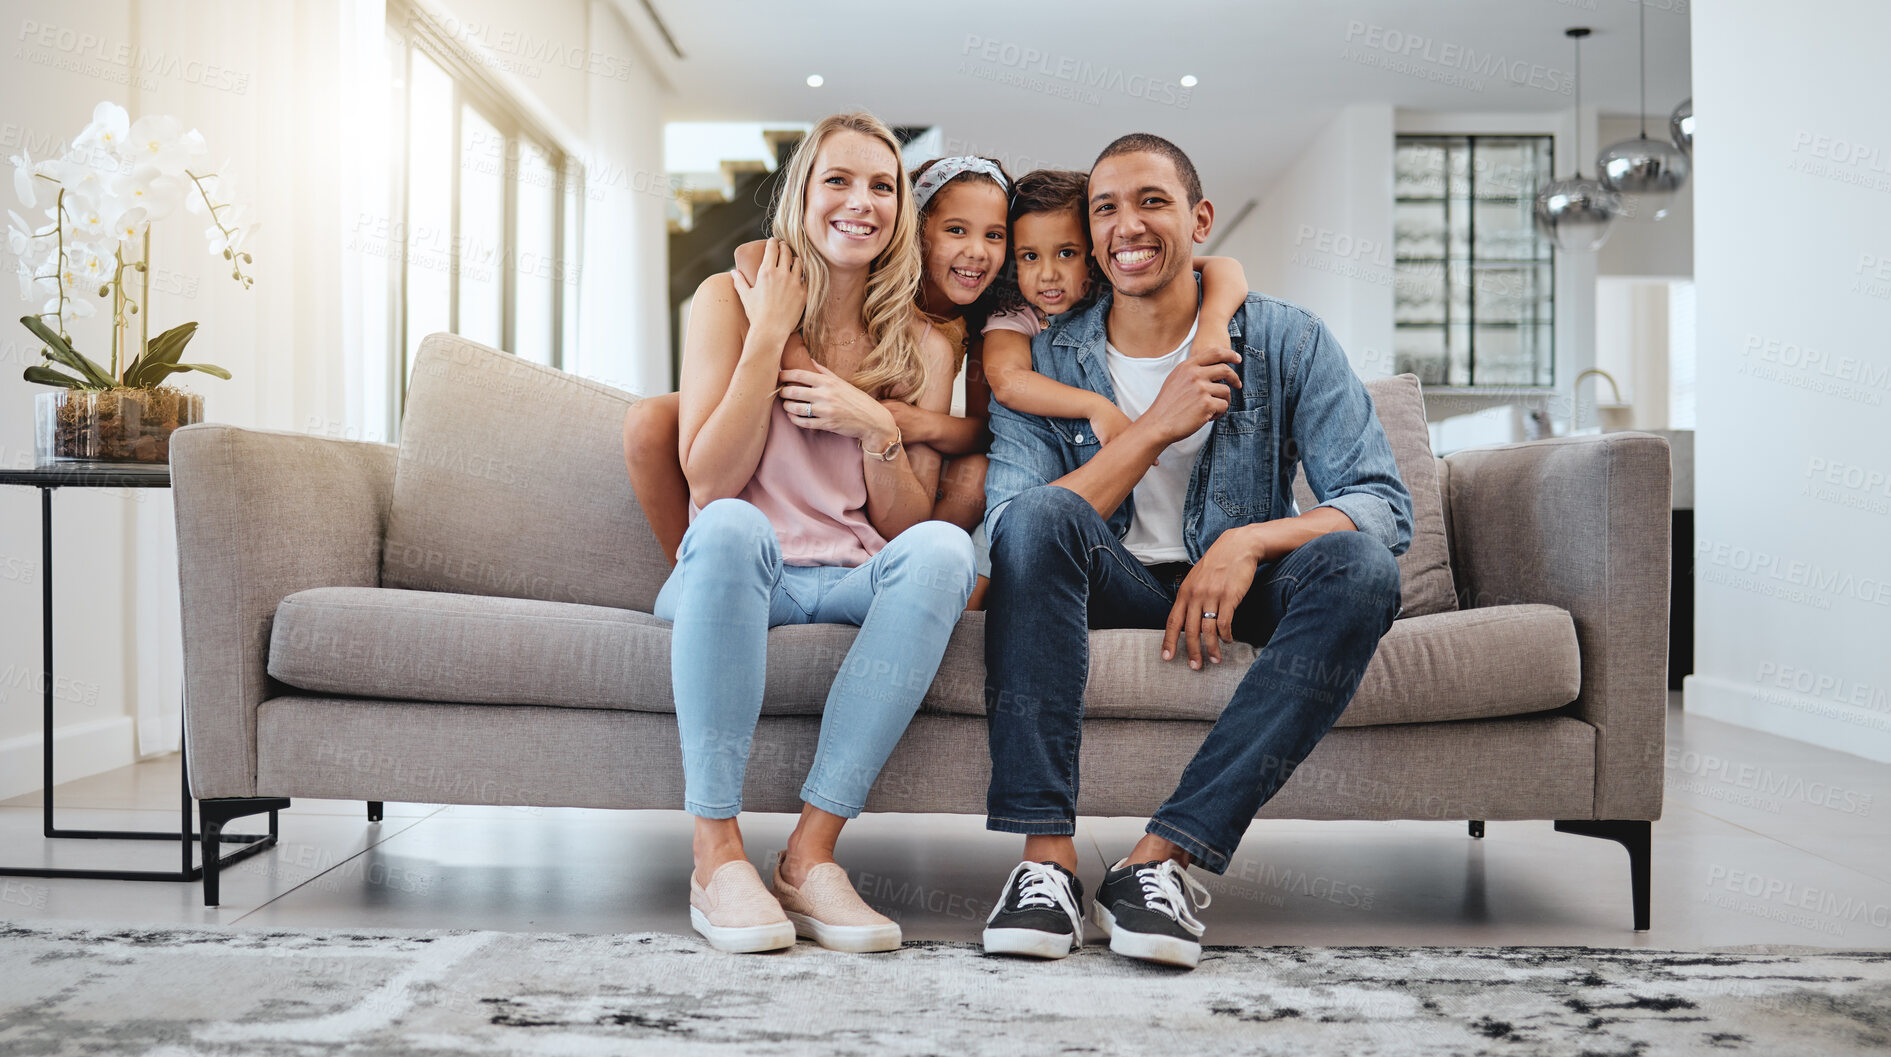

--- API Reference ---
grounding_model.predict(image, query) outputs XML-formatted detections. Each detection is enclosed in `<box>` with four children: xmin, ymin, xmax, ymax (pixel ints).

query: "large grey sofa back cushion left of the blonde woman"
<box><xmin>380</xmin><ymin>333</ymin><xmax>669</xmax><ymax>613</ymax></box>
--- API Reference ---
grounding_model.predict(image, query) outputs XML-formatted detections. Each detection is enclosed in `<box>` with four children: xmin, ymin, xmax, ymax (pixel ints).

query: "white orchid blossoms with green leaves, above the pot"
<box><xmin>8</xmin><ymin>102</ymin><xmax>259</xmax><ymax>390</ymax></box>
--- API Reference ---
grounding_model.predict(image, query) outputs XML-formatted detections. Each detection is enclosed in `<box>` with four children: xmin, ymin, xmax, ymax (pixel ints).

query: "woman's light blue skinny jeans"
<box><xmin>652</xmin><ymin>499</ymin><xmax>972</xmax><ymax>819</ymax></box>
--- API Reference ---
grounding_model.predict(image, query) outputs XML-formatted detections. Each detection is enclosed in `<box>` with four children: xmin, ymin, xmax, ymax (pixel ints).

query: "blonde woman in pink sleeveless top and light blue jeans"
<box><xmin>654</xmin><ymin>113</ymin><xmax>974</xmax><ymax>951</ymax></box>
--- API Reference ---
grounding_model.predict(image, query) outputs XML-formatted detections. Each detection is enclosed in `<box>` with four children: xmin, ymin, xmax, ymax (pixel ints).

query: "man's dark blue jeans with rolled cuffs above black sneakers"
<box><xmin>985</xmin><ymin>484</ymin><xmax>1399</xmax><ymax>874</ymax></box>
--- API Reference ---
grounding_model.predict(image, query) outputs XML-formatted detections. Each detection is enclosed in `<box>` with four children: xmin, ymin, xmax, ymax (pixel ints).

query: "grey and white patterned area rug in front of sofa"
<box><xmin>11</xmin><ymin>925</ymin><xmax>1891</xmax><ymax>1057</ymax></box>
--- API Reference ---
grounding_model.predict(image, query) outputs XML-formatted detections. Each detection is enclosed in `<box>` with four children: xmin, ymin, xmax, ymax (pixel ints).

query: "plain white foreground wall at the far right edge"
<box><xmin>1687</xmin><ymin>0</ymin><xmax>1891</xmax><ymax>760</ymax></box>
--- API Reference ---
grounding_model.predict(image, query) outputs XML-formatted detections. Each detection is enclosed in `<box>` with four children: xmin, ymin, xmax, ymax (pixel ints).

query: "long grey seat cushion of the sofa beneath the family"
<box><xmin>269</xmin><ymin>588</ymin><xmax>1581</xmax><ymax>726</ymax></box>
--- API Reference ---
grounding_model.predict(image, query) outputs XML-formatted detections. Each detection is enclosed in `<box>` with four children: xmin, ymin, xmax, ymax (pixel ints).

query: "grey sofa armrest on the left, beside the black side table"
<box><xmin>170</xmin><ymin>424</ymin><xmax>395</xmax><ymax>798</ymax></box>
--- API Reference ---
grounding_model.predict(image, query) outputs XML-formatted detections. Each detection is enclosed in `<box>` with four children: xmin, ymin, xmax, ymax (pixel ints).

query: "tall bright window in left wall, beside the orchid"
<box><xmin>388</xmin><ymin>0</ymin><xmax>584</xmax><ymax>435</ymax></box>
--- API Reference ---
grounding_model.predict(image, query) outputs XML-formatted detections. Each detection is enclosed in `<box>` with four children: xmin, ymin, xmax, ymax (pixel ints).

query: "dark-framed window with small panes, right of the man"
<box><xmin>1394</xmin><ymin>136</ymin><xmax>1556</xmax><ymax>386</ymax></box>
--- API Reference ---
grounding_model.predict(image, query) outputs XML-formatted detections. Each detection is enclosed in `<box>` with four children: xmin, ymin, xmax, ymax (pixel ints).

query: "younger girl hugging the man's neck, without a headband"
<box><xmin>983</xmin><ymin>168</ymin><xmax>1248</xmax><ymax>444</ymax></box>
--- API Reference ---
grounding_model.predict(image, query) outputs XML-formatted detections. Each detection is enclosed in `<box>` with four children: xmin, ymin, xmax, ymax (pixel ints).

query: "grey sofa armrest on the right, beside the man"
<box><xmin>1445</xmin><ymin>433</ymin><xmax>1672</xmax><ymax>819</ymax></box>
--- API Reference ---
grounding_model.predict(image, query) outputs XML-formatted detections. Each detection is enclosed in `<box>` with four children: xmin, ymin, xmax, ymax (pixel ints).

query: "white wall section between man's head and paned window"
<box><xmin>1206</xmin><ymin>104</ymin><xmax>1394</xmax><ymax>378</ymax></box>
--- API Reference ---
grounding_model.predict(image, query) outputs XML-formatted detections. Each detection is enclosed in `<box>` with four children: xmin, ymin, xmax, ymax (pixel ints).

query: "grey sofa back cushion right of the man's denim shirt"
<box><xmin>1293</xmin><ymin>374</ymin><xmax>1458</xmax><ymax>616</ymax></box>
